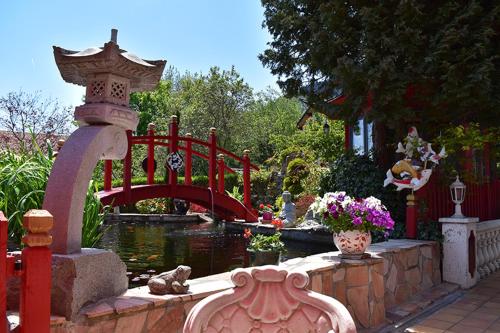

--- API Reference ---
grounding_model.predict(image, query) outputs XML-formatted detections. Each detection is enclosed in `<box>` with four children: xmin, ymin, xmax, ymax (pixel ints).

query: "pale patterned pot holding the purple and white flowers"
<box><xmin>333</xmin><ymin>230</ymin><xmax>372</xmax><ymax>259</ymax></box>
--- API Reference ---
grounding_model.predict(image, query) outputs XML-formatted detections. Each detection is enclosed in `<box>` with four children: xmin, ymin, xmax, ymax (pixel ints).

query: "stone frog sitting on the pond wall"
<box><xmin>148</xmin><ymin>265</ymin><xmax>191</xmax><ymax>295</ymax></box>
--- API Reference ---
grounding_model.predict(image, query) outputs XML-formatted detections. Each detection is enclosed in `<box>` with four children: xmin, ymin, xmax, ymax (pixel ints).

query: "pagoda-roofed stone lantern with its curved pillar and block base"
<box><xmin>43</xmin><ymin>29</ymin><xmax>166</xmax><ymax>320</ymax></box>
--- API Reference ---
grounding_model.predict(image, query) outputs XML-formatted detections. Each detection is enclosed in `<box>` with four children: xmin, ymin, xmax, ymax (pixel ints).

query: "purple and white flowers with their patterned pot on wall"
<box><xmin>312</xmin><ymin>192</ymin><xmax>394</xmax><ymax>259</ymax></box>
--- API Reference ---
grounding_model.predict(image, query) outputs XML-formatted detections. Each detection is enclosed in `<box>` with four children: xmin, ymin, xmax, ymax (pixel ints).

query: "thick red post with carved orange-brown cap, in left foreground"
<box><xmin>19</xmin><ymin>210</ymin><xmax>53</xmax><ymax>333</ymax></box>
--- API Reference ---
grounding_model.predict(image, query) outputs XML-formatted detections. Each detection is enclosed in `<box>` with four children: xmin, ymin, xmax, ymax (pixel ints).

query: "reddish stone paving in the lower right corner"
<box><xmin>406</xmin><ymin>271</ymin><xmax>500</xmax><ymax>333</ymax></box>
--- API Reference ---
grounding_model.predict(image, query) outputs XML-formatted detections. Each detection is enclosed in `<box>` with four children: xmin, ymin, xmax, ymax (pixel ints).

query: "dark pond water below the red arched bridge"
<box><xmin>97</xmin><ymin>222</ymin><xmax>335</xmax><ymax>288</ymax></box>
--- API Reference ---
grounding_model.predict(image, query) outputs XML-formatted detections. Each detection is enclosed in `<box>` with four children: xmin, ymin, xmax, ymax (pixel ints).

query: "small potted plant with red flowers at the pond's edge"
<box><xmin>243</xmin><ymin>219</ymin><xmax>285</xmax><ymax>266</ymax></box>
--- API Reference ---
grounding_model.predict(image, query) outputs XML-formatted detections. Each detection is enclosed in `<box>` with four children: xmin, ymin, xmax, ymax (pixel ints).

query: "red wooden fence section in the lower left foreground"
<box><xmin>0</xmin><ymin>210</ymin><xmax>53</xmax><ymax>333</ymax></box>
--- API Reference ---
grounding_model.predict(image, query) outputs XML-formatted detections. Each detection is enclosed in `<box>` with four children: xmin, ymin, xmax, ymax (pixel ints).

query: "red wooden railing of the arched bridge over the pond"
<box><xmin>104</xmin><ymin>116</ymin><xmax>259</xmax><ymax>209</ymax></box>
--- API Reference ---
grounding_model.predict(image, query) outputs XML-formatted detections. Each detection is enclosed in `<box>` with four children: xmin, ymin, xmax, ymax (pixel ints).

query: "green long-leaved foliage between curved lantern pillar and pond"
<box><xmin>82</xmin><ymin>181</ymin><xmax>111</xmax><ymax>247</ymax></box>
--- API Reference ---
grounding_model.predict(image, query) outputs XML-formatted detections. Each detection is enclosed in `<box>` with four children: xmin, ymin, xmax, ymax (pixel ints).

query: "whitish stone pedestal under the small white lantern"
<box><xmin>439</xmin><ymin>217</ymin><xmax>479</xmax><ymax>288</ymax></box>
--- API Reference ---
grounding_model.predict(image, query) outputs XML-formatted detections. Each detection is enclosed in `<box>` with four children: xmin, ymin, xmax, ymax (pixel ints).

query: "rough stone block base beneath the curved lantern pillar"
<box><xmin>51</xmin><ymin>248</ymin><xmax>128</xmax><ymax>320</ymax></box>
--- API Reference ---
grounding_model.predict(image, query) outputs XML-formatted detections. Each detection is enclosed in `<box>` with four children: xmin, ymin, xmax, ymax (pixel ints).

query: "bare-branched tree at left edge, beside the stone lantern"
<box><xmin>0</xmin><ymin>90</ymin><xmax>72</xmax><ymax>150</ymax></box>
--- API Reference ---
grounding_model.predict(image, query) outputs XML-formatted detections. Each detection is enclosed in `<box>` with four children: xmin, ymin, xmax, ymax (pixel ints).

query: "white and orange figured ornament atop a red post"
<box><xmin>384</xmin><ymin>127</ymin><xmax>446</xmax><ymax>191</ymax></box>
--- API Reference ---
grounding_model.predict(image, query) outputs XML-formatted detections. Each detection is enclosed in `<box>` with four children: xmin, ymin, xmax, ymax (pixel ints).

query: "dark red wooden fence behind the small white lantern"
<box><xmin>416</xmin><ymin>178</ymin><xmax>500</xmax><ymax>221</ymax></box>
